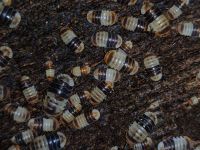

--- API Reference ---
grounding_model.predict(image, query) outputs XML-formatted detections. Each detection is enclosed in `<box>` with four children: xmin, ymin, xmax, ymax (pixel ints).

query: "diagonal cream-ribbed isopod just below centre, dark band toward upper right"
<box><xmin>88</xmin><ymin>82</ymin><xmax>113</xmax><ymax>106</ymax></box>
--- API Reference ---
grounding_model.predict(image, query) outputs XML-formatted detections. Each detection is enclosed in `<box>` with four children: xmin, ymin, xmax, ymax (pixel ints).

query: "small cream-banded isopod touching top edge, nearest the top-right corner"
<box><xmin>166</xmin><ymin>0</ymin><xmax>191</xmax><ymax>20</ymax></box>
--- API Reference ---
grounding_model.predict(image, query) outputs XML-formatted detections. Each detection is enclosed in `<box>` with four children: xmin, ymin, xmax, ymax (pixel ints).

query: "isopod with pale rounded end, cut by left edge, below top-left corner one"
<box><xmin>0</xmin><ymin>46</ymin><xmax>13</xmax><ymax>71</ymax></box>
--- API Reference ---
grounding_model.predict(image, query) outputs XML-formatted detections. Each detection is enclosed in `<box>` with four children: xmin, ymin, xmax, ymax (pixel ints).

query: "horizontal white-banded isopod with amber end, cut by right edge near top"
<box><xmin>176</xmin><ymin>22</ymin><xmax>200</xmax><ymax>37</ymax></box>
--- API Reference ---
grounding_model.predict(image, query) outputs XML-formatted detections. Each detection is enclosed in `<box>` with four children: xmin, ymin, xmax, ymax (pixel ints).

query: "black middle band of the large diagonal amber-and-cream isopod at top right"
<box><xmin>144</xmin><ymin>6</ymin><xmax>162</xmax><ymax>23</ymax></box>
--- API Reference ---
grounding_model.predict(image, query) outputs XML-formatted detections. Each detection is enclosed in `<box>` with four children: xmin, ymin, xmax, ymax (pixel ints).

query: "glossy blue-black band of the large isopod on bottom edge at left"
<box><xmin>46</xmin><ymin>133</ymin><xmax>61</xmax><ymax>150</ymax></box>
